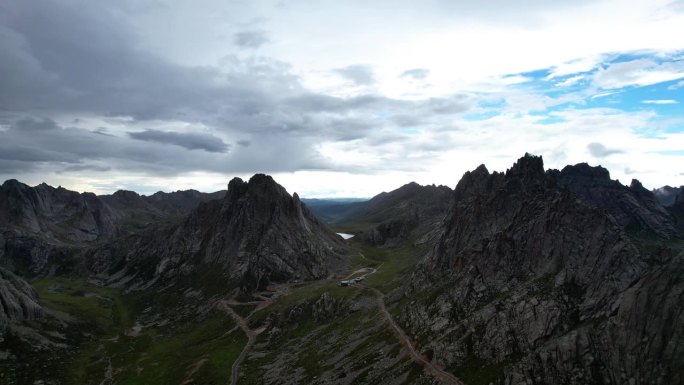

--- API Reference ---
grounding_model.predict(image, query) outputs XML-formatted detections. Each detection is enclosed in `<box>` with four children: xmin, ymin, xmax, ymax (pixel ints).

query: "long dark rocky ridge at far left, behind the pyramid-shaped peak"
<box><xmin>0</xmin><ymin>180</ymin><xmax>225</xmax><ymax>273</ymax></box>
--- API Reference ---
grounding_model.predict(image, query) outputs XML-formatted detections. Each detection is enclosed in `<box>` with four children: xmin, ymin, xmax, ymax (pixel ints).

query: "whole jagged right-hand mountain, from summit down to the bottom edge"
<box><xmin>400</xmin><ymin>155</ymin><xmax>684</xmax><ymax>384</ymax></box>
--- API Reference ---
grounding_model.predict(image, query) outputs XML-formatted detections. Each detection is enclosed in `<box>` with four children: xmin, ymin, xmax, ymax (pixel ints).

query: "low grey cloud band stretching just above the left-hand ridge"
<box><xmin>0</xmin><ymin>118</ymin><xmax>330</xmax><ymax>176</ymax></box>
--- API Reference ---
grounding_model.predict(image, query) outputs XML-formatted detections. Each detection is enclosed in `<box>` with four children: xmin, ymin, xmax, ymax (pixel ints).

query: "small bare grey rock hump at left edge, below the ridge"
<box><xmin>0</xmin><ymin>267</ymin><xmax>43</xmax><ymax>333</ymax></box>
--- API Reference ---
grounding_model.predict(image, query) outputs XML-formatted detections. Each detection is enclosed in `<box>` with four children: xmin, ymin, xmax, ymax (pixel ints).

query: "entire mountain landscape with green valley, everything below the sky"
<box><xmin>0</xmin><ymin>154</ymin><xmax>684</xmax><ymax>385</ymax></box>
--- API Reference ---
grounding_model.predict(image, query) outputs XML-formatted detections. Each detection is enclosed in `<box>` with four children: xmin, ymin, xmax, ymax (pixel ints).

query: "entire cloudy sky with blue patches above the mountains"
<box><xmin>0</xmin><ymin>0</ymin><xmax>684</xmax><ymax>197</ymax></box>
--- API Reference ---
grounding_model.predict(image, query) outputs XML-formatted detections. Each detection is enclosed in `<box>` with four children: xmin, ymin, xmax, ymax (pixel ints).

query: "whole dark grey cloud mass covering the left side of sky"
<box><xmin>0</xmin><ymin>0</ymin><xmax>471</xmax><ymax>175</ymax></box>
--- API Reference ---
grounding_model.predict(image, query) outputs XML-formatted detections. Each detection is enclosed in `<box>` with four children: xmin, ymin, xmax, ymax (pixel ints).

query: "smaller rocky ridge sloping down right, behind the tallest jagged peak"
<box><xmin>551</xmin><ymin>163</ymin><xmax>677</xmax><ymax>237</ymax></box>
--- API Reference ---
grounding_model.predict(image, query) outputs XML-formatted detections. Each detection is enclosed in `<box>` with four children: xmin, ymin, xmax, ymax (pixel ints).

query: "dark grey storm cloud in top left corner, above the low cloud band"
<box><xmin>0</xmin><ymin>0</ymin><xmax>292</xmax><ymax>119</ymax></box>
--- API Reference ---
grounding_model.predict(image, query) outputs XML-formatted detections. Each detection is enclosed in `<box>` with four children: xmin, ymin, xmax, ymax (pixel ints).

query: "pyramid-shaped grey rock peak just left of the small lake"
<box><xmin>90</xmin><ymin>174</ymin><xmax>346</xmax><ymax>290</ymax></box>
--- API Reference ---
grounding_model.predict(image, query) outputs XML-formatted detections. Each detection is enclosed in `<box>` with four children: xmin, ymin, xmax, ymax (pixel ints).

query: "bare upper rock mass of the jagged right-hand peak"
<box><xmin>425</xmin><ymin>154</ymin><xmax>643</xmax><ymax>312</ymax></box>
